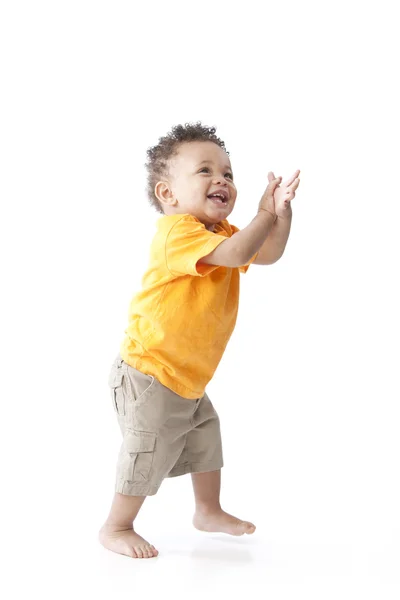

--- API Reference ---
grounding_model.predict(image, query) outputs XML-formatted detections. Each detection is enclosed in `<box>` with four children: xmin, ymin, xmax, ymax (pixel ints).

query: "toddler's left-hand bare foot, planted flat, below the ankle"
<box><xmin>99</xmin><ymin>525</ymin><xmax>158</xmax><ymax>558</ymax></box>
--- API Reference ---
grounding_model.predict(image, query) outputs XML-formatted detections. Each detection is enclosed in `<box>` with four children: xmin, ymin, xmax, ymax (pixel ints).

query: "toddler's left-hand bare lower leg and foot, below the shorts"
<box><xmin>99</xmin><ymin>493</ymin><xmax>158</xmax><ymax>558</ymax></box>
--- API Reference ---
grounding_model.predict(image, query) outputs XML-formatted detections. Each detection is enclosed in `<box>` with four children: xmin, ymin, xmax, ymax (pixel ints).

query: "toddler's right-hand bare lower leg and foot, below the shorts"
<box><xmin>192</xmin><ymin>470</ymin><xmax>256</xmax><ymax>535</ymax></box>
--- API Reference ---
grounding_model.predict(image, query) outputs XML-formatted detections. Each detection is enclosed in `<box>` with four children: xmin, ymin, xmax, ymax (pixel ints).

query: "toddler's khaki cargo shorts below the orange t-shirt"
<box><xmin>108</xmin><ymin>354</ymin><xmax>223</xmax><ymax>496</ymax></box>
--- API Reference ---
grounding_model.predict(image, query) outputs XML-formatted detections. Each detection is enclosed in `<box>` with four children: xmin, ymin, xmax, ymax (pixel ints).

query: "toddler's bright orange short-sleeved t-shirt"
<box><xmin>120</xmin><ymin>214</ymin><xmax>256</xmax><ymax>400</ymax></box>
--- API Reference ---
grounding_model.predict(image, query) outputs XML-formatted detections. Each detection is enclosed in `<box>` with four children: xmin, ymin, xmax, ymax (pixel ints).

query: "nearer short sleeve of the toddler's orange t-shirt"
<box><xmin>165</xmin><ymin>216</ymin><xmax>227</xmax><ymax>277</ymax></box>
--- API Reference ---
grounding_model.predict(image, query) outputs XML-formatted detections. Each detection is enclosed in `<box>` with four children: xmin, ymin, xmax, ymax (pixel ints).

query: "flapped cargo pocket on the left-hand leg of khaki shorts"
<box><xmin>124</xmin><ymin>429</ymin><xmax>157</xmax><ymax>483</ymax></box>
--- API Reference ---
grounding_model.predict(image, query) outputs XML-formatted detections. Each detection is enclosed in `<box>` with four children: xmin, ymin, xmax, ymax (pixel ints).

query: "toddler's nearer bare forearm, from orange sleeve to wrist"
<box><xmin>199</xmin><ymin>210</ymin><xmax>276</xmax><ymax>267</ymax></box>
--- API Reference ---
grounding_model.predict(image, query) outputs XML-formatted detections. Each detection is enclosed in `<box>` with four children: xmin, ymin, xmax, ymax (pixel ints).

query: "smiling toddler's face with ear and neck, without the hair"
<box><xmin>155</xmin><ymin>142</ymin><xmax>237</xmax><ymax>231</ymax></box>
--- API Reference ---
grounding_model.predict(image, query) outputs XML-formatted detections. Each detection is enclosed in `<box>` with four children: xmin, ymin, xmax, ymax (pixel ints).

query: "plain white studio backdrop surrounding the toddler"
<box><xmin>0</xmin><ymin>0</ymin><xmax>400</xmax><ymax>600</ymax></box>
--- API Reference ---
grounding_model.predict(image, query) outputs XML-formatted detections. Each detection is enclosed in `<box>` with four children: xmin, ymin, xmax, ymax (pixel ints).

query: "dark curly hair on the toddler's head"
<box><xmin>145</xmin><ymin>122</ymin><xmax>229</xmax><ymax>214</ymax></box>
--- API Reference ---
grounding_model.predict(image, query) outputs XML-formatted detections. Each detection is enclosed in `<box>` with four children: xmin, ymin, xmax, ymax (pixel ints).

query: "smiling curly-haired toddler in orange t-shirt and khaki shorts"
<box><xmin>99</xmin><ymin>123</ymin><xmax>300</xmax><ymax>558</ymax></box>
